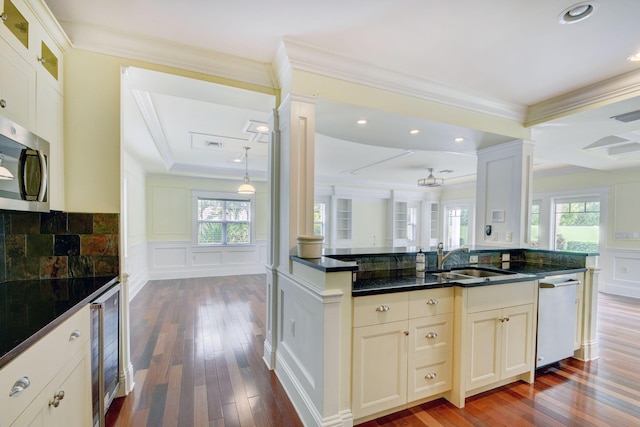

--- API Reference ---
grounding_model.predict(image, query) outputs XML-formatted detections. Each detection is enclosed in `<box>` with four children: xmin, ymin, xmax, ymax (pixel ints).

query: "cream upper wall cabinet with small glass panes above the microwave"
<box><xmin>0</xmin><ymin>0</ymin><xmax>68</xmax><ymax>210</ymax></box>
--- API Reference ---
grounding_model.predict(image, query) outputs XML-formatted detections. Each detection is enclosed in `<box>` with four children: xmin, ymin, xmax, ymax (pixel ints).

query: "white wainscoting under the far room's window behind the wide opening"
<box><xmin>148</xmin><ymin>240</ymin><xmax>267</xmax><ymax>280</ymax></box>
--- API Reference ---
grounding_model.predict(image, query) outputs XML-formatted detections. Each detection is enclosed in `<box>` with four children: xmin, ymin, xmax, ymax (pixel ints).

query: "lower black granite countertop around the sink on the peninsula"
<box><xmin>351</xmin><ymin>262</ymin><xmax>587</xmax><ymax>297</ymax></box>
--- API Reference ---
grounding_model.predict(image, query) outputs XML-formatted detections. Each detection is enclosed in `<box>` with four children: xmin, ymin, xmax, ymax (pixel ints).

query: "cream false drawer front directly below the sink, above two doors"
<box><xmin>467</xmin><ymin>281</ymin><xmax>538</xmax><ymax>313</ymax></box>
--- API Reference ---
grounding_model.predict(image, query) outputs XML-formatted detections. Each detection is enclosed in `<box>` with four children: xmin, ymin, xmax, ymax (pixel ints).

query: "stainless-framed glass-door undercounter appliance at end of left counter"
<box><xmin>91</xmin><ymin>283</ymin><xmax>120</xmax><ymax>427</ymax></box>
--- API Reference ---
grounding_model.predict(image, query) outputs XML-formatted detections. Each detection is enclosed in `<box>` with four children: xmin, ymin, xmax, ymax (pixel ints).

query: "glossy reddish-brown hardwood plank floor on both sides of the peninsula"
<box><xmin>107</xmin><ymin>275</ymin><xmax>640</xmax><ymax>427</ymax></box>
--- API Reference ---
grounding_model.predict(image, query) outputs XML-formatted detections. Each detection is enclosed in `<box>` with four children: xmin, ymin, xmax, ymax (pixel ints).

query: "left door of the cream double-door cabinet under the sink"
<box><xmin>462</xmin><ymin>310</ymin><xmax>503</xmax><ymax>390</ymax></box>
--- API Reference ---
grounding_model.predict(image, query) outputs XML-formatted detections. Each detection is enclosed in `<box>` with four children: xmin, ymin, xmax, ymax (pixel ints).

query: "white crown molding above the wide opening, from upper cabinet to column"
<box><xmin>61</xmin><ymin>21</ymin><xmax>276</xmax><ymax>88</ymax></box>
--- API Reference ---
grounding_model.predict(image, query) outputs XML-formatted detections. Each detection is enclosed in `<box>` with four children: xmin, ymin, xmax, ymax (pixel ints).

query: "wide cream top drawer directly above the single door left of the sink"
<box><xmin>353</xmin><ymin>292</ymin><xmax>409</xmax><ymax>327</ymax></box>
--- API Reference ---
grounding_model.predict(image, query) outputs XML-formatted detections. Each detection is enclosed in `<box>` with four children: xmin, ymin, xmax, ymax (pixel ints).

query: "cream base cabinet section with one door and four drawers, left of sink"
<box><xmin>352</xmin><ymin>288</ymin><xmax>453</xmax><ymax>419</ymax></box>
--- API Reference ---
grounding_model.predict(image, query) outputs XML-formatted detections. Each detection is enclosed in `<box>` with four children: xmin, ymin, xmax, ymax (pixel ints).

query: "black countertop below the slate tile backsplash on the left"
<box><xmin>0</xmin><ymin>276</ymin><xmax>118</xmax><ymax>368</ymax></box>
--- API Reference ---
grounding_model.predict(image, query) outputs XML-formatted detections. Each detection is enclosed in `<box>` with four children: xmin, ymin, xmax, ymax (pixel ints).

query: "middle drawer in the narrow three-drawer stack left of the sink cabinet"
<box><xmin>409</xmin><ymin>313</ymin><xmax>453</xmax><ymax>360</ymax></box>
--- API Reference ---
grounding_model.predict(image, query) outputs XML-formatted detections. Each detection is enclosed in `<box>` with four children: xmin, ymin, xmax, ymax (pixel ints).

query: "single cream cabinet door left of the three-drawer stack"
<box><xmin>352</xmin><ymin>321</ymin><xmax>408</xmax><ymax>418</ymax></box>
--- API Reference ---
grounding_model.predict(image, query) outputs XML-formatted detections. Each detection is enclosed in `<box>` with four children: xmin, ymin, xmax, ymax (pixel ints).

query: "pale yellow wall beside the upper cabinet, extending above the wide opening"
<box><xmin>64</xmin><ymin>49</ymin><xmax>278</xmax><ymax>213</ymax></box>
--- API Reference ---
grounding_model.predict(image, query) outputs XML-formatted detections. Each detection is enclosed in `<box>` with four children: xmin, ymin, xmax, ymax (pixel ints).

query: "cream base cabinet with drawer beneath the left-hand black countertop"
<box><xmin>0</xmin><ymin>306</ymin><xmax>92</xmax><ymax>427</ymax></box>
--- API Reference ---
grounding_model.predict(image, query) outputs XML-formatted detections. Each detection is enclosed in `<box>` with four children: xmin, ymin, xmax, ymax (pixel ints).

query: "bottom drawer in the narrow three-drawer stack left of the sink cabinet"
<box><xmin>407</xmin><ymin>353</ymin><xmax>453</xmax><ymax>402</ymax></box>
